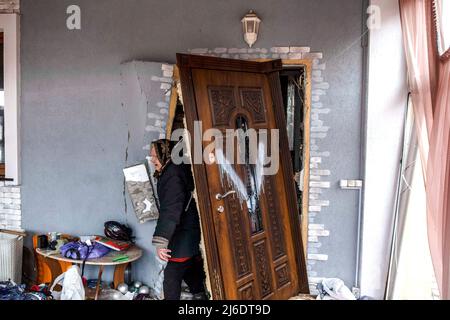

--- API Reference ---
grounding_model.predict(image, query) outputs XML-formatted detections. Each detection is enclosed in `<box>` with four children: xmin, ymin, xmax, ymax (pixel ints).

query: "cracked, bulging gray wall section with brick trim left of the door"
<box><xmin>121</xmin><ymin>61</ymin><xmax>173</xmax><ymax>293</ymax></box>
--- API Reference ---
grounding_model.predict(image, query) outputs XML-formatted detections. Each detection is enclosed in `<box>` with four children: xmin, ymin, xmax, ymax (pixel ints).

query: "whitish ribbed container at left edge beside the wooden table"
<box><xmin>0</xmin><ymin>232</ymin><xmax>23</xmax><ymax>284</ymax></box>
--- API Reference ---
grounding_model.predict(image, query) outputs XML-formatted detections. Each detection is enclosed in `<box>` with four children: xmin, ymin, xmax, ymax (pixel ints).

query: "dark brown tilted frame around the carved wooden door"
<box><xmin>177</xmin><ymin>53</ymin><xmax>309</xmax><ymax>300</ymax></box>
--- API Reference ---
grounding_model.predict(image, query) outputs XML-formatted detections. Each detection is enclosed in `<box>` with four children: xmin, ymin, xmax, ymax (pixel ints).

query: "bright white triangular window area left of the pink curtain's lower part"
<box><xmin>387</xmin><ymin>101</ymin><xmax>440</xmax><ymax>300</ymax></box>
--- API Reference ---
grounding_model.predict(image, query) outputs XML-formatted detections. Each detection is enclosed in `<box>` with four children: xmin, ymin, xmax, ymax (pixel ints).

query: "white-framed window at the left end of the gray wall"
<box><xmin>0</xmin><ymin>13</ymin><xmax>19</xmax><ymax>185</ymax></box>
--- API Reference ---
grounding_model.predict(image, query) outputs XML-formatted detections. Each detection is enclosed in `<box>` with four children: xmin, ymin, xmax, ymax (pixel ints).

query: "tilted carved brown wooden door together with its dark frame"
<box><xmin>177</xmin><ymin>54</ymin><xmax>308</xmax><ymax>300</ymax></box>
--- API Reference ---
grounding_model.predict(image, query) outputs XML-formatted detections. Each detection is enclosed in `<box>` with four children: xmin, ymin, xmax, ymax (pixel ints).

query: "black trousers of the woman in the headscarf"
<box><xmin>163</xmin><ymin>256</ymin><xmax>205</xmax><ymax>300</ymax></box>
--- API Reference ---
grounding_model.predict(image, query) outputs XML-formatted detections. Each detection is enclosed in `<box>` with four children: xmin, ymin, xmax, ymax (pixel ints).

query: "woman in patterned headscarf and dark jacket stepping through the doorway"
<box><xmin>150</xmin><ymin>139</ymin><xmax>205</xmax><ymax>300</ymax></box>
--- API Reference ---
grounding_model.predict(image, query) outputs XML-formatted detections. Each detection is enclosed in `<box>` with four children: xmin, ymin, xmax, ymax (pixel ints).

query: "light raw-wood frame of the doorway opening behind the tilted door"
<box><xmin>166</xmin><ymin>59</ymin><xmax>312</xmax><ymax>259</ymax></box>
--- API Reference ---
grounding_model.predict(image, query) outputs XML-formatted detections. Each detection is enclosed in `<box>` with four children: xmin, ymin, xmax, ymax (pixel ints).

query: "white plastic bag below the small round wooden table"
<box><xmin>50</xmin><ymin>265</ymin><xmax>85</xmax><ymax>300</ymax></box>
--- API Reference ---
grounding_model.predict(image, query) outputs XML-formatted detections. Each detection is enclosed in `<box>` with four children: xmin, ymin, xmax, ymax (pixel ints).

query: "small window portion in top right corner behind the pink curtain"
<box><xmin>434</xmin><ymin>0</ymin><xmax>450</xmax><ymax>55</ymax></box>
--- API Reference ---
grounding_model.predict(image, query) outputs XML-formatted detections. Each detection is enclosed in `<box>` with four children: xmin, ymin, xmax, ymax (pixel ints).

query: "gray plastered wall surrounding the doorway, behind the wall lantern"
<box><xmin>20</xmin><ymin>0</ymin><xmax>362</xmax><ymax>286</ymax></box>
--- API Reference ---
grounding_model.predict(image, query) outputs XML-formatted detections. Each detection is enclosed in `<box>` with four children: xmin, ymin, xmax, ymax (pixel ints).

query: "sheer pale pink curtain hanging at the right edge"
<box><xmin>399</xmin><ymin>0</ymin><xmax>450</xmax><ymax>299</ymax></box>
